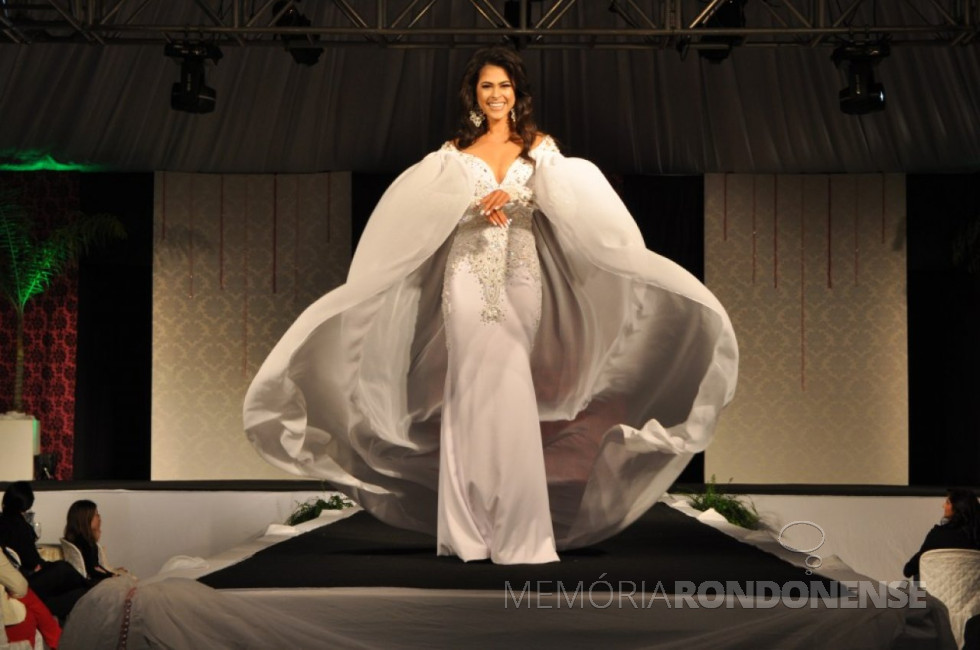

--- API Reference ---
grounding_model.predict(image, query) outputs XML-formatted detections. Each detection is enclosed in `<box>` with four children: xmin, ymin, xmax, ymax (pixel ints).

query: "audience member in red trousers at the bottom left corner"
<box><xmin>0</xmin><ymin>553</ymin><xmax>61</xmax><ymax>650</ymax></box>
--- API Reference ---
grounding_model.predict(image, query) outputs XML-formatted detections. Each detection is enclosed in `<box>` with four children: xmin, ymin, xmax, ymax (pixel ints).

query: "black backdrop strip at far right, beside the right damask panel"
<box><xmin>906</xmin><ymin>174</ymin><xmax>980</xmax><ymax>486</ymax></box>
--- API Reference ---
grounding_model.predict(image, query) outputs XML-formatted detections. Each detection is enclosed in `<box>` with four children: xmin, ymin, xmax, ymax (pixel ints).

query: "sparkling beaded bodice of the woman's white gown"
<box><xmin>442</xmin><ymin>136</ymin><xmax>558</xmax><ymax>323</ymax></box>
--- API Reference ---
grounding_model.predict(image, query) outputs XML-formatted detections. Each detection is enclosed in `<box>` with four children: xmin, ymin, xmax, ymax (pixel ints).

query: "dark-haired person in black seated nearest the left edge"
<box><xmin>0</xmin><ymin>481</ymin><xmax>89</xmax><ymax>621</ymax></box>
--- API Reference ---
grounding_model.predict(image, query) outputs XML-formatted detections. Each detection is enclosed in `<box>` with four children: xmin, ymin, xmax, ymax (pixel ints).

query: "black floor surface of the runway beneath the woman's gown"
<box><xmin>200</xmin><ymin>503</ymin><xmax>831</xmax><ymax>594</ymax></box>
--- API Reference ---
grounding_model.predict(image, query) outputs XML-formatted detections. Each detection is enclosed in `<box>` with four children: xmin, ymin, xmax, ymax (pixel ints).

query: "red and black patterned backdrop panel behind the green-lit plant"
<box><xmin>0</xmin><ymin>172</ymin><xmax>79</xmax><ymax>480</ymax></box>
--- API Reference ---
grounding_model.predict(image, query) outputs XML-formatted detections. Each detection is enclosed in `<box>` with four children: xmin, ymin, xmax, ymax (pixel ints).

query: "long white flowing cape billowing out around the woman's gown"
<box><xmin>244</xmin><ymin>146</ymin><xmax>738</xmax><ymax>548</ymax></box>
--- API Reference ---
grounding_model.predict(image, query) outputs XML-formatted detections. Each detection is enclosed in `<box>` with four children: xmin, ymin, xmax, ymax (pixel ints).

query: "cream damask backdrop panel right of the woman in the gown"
<box><xmin>705</xmin><ymin>174</ymin><xmax>908</xmax><ymax>485</ymax></box>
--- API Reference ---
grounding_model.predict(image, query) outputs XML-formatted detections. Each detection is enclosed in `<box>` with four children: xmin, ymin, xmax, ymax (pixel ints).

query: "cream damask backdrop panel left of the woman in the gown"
<box><xmin>151</xmin><ymin>172</ymin><xmax>351</xmax><ymax>480</ymax></box>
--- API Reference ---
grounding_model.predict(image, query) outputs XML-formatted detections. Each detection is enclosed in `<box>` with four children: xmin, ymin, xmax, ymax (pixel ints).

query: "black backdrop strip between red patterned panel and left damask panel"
<box><xmin>74</xmin><ymin>173</ymin><xmax>153</xmax><ymax>480</ymax></box>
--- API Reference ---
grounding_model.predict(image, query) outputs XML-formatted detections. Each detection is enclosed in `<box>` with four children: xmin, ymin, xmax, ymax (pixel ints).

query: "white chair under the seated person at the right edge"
<box><xmin>919</xmin><ymin>548</ymin><xmax>980</xmax><ymax>648</ymax></box>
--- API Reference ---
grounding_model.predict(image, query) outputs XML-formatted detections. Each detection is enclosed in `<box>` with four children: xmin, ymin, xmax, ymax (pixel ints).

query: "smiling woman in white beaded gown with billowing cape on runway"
<box><xmin>244</xmin><ymin>46</ymin><xmax>738</xmax><ymax>564</ymax></box>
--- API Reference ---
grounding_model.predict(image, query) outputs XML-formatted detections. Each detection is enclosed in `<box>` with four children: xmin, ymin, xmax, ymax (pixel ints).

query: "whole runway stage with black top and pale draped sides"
<box><xmin>57</xmin><ymin>496</ymin><xmax>953</xmax><ymax>650</ymax></box>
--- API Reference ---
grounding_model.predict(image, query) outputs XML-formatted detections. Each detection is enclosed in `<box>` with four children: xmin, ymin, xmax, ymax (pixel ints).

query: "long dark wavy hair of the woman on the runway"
<box><xmin>455</xmin><ymin>45</ymin><xmax>538</xmax><ymax>160</ymax></box>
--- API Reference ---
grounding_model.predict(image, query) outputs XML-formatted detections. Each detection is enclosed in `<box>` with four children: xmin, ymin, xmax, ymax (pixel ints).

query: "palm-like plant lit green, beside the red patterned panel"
<box><xmin>0</xmin><ymin>189</ymin><xmax>126</xmax><ymax>411</ymax></box>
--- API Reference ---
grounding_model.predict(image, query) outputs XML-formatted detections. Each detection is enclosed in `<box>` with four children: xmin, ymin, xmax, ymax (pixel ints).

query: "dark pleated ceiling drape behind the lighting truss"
<box><xmin>0</xmin><ymin>1</ymin><xmax>980</xmax><ymax>174</ymax></box>
